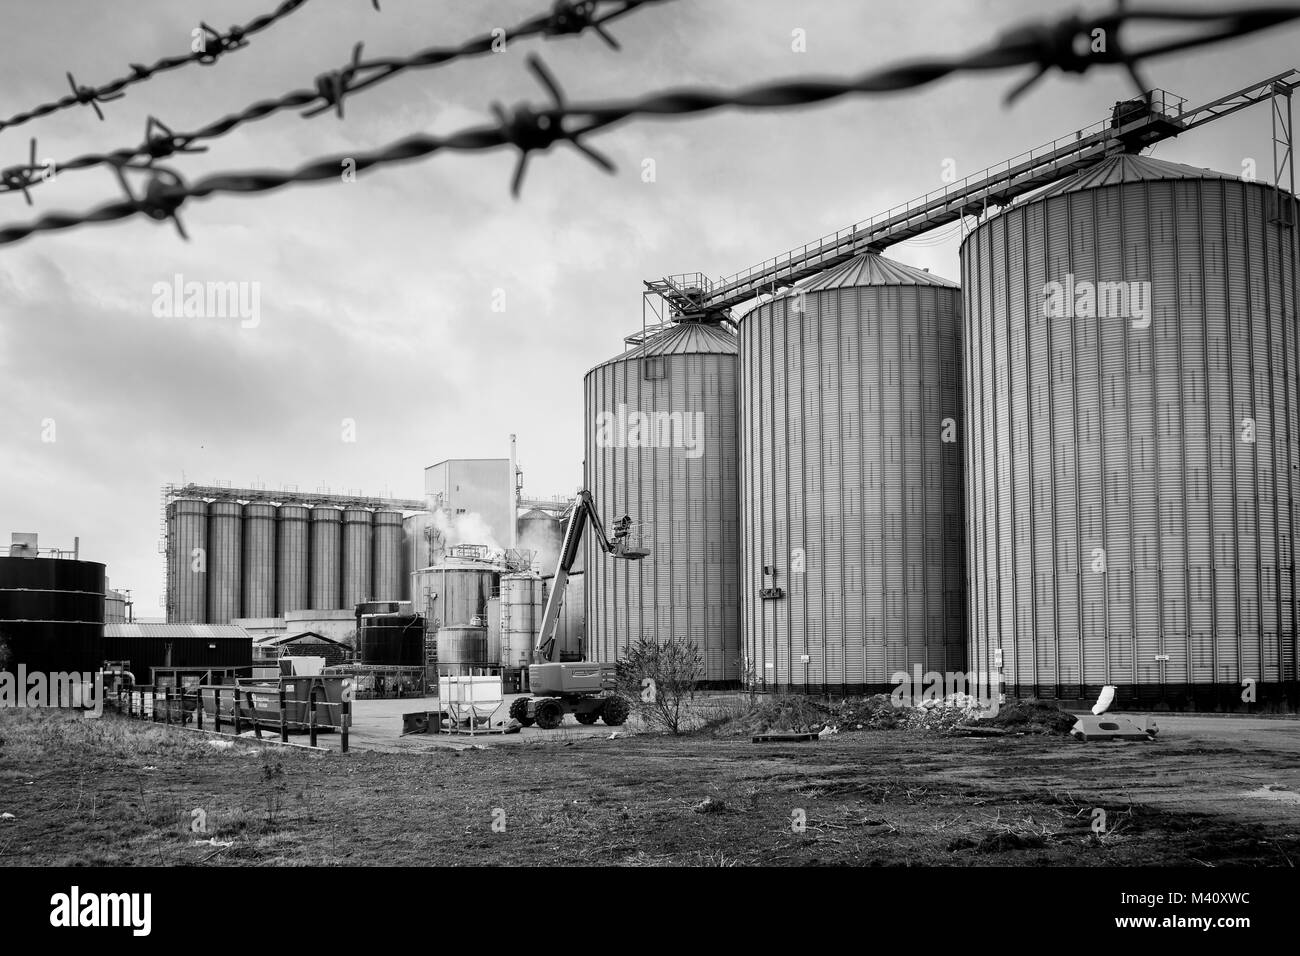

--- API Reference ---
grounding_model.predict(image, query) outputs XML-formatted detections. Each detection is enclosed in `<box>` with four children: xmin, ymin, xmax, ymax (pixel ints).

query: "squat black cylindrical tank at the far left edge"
<box><xmin>0</xmin><ymin>554</ymin><xmax>104</xmax><ymax>671</ymax></box>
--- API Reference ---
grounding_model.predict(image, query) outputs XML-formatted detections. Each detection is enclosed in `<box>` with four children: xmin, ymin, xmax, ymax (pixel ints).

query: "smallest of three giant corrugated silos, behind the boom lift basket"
<box><xmin>584</xmin><ymin>321</ymin><xmax>740</xmax><ymax>684</ymax></box>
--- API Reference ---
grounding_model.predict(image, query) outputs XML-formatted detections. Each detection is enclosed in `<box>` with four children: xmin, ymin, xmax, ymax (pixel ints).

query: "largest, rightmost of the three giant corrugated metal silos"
<box><xmin>961</xmin><ymin>156</ymin><xmax>1300</xmax><ymax>708</ymax></box>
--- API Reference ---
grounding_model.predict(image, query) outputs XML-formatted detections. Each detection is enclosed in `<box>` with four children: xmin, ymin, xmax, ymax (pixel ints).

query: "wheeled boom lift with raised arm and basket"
<box><xmin>510</xmin><ymin>490</ymin><xmax>650</xmax><ymax>730</ymax></box>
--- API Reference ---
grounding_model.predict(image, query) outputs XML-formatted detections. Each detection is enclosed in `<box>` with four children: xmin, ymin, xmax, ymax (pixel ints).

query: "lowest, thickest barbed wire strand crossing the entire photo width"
<box><xmin>0</xmin><ymin>7</ymin><xmax>1300</xmax><ymax>245</ymax></box>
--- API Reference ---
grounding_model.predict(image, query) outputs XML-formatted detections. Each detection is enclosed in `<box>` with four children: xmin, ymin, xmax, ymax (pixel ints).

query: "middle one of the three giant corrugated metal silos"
<box><xmin>740</xmin><ymin>252</ymin><xmax>966</xmax><ymax>693</ymax></box>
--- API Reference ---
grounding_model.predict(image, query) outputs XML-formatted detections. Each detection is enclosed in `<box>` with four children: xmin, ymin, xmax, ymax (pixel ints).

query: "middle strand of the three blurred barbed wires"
<box><xmin>0</xmin><ymin>0</ymin><xmax>667</xmax><ymax>206</ymax></box>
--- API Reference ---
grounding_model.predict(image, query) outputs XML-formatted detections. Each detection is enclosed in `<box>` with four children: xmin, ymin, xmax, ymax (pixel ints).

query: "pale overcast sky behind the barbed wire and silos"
<box><xmin>0</xmin><ymin>0</ymin><xmax>1300</xmax><ymax>617</ymax></box>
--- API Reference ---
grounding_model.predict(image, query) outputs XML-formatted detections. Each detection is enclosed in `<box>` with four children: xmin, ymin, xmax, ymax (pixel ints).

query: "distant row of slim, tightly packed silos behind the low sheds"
<box><xmin>166</xmin><ymin>498</ymin><xmax>404</xmax><ymax>624</ymax></box>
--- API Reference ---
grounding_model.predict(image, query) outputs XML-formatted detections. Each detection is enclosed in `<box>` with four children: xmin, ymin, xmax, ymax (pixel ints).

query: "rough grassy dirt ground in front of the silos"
<box><xmin>0</xmin><ymin>701</ymin><xmax>1300</xmax><ymax>866</ymax></box>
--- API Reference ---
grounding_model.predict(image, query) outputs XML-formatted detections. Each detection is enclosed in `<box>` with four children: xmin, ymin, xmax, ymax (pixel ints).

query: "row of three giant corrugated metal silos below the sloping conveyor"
<box><xmin>585</xmin><ymin>155</ymin><xmax>1300</xmax><ymax>704</ymax></box>
